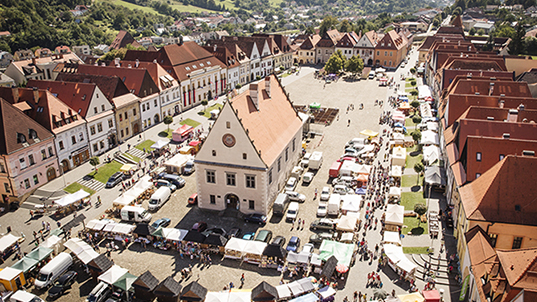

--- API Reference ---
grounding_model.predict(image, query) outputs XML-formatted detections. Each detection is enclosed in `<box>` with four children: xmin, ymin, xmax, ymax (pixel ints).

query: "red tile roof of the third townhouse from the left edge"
<box><xmin>26</xmin><ymin>80</ymin><xmax>97</xmax><ymax>118</ymax></box>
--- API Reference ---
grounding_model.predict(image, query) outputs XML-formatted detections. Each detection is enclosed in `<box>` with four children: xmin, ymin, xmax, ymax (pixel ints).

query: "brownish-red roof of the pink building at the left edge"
<box><xmin>0</xmin><ymin>98</ymin><xmax>54</xmax><ymax>155</ymax></box>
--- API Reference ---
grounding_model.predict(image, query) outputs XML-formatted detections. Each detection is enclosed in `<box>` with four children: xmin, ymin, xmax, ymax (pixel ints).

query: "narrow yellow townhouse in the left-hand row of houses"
<box><xmin>112</xmin><ymin>93</ymin><xmax>141</xmax><ymax>142</ymax></box>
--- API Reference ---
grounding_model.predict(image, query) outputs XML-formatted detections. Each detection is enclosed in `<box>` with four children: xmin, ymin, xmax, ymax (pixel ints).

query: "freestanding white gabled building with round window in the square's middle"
<box><xmin>195</xmin><ymin>76</ymin><xmax>302</xmax><ymax>214</ymax></box>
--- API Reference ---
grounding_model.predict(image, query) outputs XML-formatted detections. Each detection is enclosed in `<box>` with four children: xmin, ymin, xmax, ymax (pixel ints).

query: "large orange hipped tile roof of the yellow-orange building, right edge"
<box><xmin>459</xmin><ymin>155</ymin><xmax>537</xmax><ymax>225</ymax></box>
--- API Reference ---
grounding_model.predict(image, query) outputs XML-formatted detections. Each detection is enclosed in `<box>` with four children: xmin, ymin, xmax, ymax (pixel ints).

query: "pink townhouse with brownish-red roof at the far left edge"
<box><xmin>0</xmin><ymin>99</ymin><xmax>59</xmax><ymax>203</ymax></box>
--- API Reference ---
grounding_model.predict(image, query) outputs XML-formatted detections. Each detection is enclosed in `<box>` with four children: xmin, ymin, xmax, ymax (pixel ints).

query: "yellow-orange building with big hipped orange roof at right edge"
<box><xmin>455</xmin><ymin>155</ymin><xmax>537</xmax><ymax>259</ymax></box>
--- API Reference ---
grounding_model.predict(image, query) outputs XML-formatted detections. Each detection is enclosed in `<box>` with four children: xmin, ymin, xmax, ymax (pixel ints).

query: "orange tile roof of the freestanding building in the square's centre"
<box><xmin>230</xmin><ymin>76</ymin><xmax>302</xmax><ymax>167</ymax></box>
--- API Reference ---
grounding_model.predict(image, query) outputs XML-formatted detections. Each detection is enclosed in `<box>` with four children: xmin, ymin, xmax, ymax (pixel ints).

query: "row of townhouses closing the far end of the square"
<box><xmin>292</xmin><ymin>28</ymin><xmax>412</xmax><ymax>69</ymax></box>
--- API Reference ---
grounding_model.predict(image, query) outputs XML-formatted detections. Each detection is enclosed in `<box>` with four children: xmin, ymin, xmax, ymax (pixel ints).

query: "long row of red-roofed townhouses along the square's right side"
<box><xmin>419</xmin><ymin>19</ymin><xmax>537</xmax><ymax>301</ymax></box>
